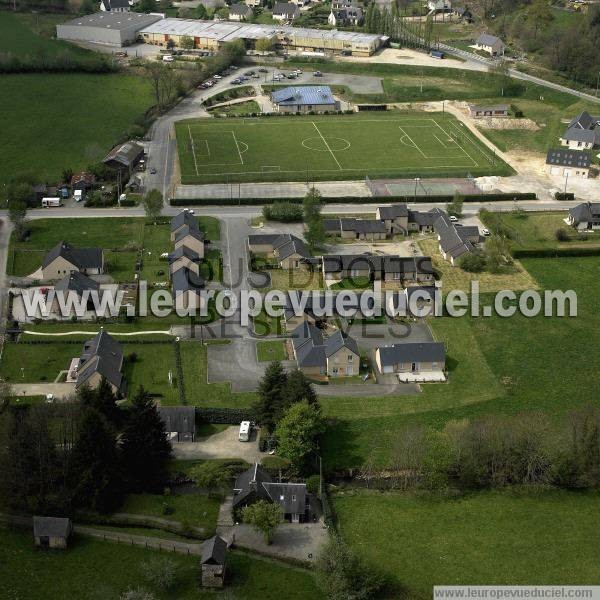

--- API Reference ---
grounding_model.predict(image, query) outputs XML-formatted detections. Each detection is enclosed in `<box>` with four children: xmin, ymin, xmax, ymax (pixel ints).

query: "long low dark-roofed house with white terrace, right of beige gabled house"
<box><xmin>375</xmin><ymin>342</ymin><xmax>446</xmax><ymax>382</ymax></box>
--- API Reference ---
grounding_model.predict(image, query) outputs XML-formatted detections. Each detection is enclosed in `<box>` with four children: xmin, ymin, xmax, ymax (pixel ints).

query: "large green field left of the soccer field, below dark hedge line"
<box><xmin>0</xmin><ymin>73</ymin><xmax>153</xmax><ymax>183</ymax></box>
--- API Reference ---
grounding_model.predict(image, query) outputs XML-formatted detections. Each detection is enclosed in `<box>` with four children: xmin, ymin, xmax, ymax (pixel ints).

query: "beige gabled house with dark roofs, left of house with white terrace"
<box><xmin>292</xmin><ymin>321</ymin><xmax>360</xmax><ymax>377</ymax></box>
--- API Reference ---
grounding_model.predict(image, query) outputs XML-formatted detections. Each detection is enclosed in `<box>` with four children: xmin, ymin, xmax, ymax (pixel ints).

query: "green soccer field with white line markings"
<box><xmin>176</xmin><ymin>113</ymin><xmax>511</xmax><ymax>184</ymax></box>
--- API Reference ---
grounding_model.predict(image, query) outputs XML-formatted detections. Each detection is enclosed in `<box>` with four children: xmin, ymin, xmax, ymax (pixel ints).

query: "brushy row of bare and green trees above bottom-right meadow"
<box><xmin>362</xmin><ymin>407</ymin><xmax>600</xmax><ymax>489</ymax></box>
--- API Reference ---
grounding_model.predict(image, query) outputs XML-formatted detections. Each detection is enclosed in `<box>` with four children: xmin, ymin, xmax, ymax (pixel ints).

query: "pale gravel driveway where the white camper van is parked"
<box><xmin>173</xmin><ymin>425</ymin><xmax>266</xmax><ymax>464</ymax></box>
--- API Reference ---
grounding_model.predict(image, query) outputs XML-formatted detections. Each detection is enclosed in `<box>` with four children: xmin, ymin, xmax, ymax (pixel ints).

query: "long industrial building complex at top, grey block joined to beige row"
<box><xmin>56</xmin><ymin>12</ymin><xmax>388</xmax><ymax>56</ymax></box>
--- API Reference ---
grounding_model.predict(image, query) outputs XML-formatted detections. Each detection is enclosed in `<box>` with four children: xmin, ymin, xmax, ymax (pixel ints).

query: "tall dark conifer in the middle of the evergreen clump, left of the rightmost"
<box><xmin>70</xmin><ymin>408</ymin><xmax>123</xmax><ymax>513</ymax></box>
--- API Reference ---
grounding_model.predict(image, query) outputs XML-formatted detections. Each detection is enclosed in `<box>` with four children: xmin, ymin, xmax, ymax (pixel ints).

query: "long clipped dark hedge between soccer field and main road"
<box><xmin>170</xmin><ymin>192</ymin><xmax>537</xmax><ymax>206</ymax></box>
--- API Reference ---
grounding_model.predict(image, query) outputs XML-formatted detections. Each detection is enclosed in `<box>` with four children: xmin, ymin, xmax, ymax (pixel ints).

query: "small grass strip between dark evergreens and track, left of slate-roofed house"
<box><xmin>119</xmin><ymin>494</ymin><xmax>220</xmax><ymax>538</ymax></box>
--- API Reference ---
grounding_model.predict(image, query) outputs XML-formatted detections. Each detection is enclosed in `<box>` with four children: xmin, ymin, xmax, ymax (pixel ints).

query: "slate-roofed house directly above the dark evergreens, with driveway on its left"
<box><xmin>75</xmin><ymin>330</ymin><xmax>127</xmax><ymax>396</ymax></box>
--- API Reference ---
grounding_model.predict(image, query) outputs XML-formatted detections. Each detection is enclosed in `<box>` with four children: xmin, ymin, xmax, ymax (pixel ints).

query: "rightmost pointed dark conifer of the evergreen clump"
<box><xmin>121</xmin><ymin>387</ymin><xmax>171</xmax><ymax>491</ymax></box>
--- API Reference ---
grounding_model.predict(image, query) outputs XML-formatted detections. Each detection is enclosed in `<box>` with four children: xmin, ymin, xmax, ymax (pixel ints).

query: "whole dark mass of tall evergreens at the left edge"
<box><xmin>0</xmin><ymin>381</ymin><xmax>171</xmax><ymax>514</ymax></box>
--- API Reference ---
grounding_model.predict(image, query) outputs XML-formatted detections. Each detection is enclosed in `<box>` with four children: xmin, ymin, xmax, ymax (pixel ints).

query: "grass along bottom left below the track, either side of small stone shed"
<box><xmin>0</xmin><ymin>529</ymin><xmax>321</xmax><ymax>600</ymax></box>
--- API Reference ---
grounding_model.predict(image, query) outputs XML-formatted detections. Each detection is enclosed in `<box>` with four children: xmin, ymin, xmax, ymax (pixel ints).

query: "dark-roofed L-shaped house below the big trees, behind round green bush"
<box><xmin>233</xmin><ymin>463</ymin><xmax>309</xmax><ymax>523</ymax></box>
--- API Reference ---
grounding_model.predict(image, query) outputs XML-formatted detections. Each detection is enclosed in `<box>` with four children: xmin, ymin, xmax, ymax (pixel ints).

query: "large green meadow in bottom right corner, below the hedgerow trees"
<box><xmin>334</xmin><ymin>490</ymin><xmax>600</xmax><ymax>598</ymax></box>
